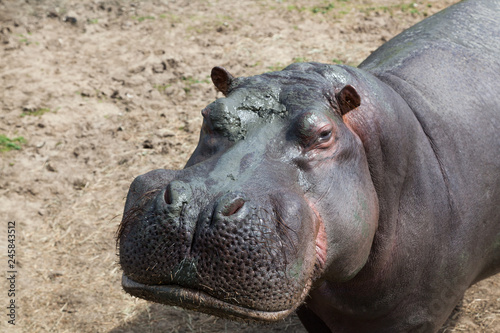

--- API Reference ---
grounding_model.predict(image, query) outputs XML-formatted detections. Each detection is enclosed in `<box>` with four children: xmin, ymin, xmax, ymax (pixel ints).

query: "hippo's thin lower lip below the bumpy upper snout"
<box><xmin>122</xmin><ymin>274</ymin><xmax>300</xmax><ymax>322</ymax></box>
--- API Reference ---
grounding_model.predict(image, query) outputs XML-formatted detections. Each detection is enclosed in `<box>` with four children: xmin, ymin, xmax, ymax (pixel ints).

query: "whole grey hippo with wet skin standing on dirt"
<box><xmin>118</xmin><ymin>0</ymin><xmax>500</xmax><ymax>332</ymax></box>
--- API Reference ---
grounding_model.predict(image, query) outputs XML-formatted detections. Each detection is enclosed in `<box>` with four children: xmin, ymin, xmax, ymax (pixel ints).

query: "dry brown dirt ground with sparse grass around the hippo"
<box><xmin>0</xmin><ymin>0</ymin><xmax>500</xmax><ymax>333</ymax></box>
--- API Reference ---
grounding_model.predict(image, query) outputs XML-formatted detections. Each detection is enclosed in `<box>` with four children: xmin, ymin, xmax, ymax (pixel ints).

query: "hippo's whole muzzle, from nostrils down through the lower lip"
<box><xmin>118</xmin><ymin>169</ymin><xmax>326</xmax><ymax>322</ymax></box>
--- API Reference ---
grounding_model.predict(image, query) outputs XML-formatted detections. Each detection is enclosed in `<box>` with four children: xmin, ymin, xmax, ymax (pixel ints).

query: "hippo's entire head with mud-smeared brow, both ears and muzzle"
<box><xmin>118</xmin><ymin>63</ymin><xmax>378</xmax><ymax>321</ymax></box>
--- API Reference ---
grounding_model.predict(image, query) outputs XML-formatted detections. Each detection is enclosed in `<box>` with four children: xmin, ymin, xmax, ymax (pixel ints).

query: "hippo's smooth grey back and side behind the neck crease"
<box><xmin>359</xmin><ymin>0</ymin><xmax>500</xmax><ymax>279</ymax></box>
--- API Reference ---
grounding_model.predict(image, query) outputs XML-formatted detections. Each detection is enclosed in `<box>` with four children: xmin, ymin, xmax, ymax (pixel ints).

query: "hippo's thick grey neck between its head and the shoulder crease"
<box><xmin>337</xmin><ymin>68</ymin><xmax>450</xmax><ymax>299</ymax></box>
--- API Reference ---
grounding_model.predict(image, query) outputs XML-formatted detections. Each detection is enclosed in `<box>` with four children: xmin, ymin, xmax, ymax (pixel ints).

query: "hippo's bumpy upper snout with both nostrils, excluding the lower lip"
<box><xmin>119</xmin><ymin>172</ymin><xmax>314</xmax><ymax>311</ymax></box>
